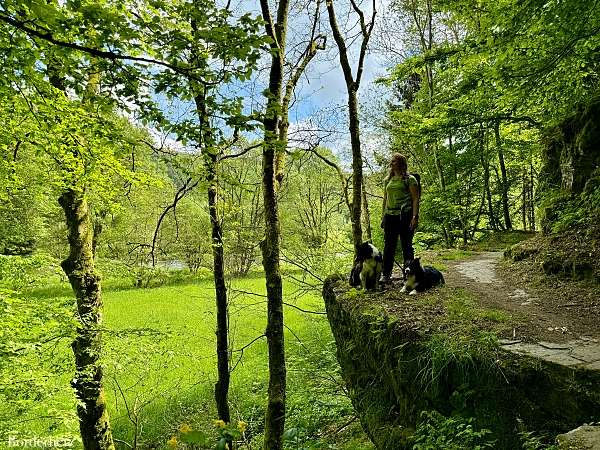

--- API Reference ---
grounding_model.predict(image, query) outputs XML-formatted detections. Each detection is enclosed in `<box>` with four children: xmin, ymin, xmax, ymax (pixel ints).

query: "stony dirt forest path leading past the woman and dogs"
<box><xmin>444</xmin><ymin>252</ymin><xmax>600</xmax><ymax>371</ymax></box>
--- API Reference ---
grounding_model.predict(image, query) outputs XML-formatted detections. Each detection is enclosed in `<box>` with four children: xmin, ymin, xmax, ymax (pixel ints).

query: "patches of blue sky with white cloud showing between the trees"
<box><xmin>150</xmin><ymin>0</ymin><xmax>388</xmax><ymax>164</ymax></box>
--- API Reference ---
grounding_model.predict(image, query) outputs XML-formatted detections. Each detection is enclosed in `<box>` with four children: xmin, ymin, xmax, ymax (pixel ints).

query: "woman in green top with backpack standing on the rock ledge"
<box><xmin>381</xmin><ymin>153</ymin><xmax>419</xmax><ymax>283</ymax></box>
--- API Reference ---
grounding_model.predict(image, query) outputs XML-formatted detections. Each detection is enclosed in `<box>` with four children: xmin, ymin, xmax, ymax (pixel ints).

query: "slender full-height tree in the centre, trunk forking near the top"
<box><xmin>260</xmin><ymin>0</ymin><xmax>325</xmax><ymax>444</ymax></box>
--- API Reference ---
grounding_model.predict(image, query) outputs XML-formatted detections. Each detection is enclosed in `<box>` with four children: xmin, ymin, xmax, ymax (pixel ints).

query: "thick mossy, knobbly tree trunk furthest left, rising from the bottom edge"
<box><xmin>58</xmin><ymin>189</ymin><xmax>115</xmax><ymax>450</ymax></box>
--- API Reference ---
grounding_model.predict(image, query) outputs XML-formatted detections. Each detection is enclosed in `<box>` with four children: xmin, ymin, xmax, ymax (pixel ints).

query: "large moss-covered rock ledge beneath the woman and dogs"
<box><xmin>323</xmin><ymin>277</ymin><xmax>600</xmax><ymax>450</ymax></box>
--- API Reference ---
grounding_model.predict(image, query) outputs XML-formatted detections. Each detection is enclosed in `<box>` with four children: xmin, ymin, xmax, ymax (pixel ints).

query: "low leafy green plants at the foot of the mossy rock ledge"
<box><xmin>412</xmin><ymin>411</ymin><xmax>495</xmax><ymax>450</ymax></box>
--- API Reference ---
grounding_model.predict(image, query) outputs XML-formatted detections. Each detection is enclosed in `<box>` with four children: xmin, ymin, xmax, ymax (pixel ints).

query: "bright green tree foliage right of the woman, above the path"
<box><xmin>385</xmin><ymin>0</ymin><xmax>600</xmax><ymax>241</ymax></box>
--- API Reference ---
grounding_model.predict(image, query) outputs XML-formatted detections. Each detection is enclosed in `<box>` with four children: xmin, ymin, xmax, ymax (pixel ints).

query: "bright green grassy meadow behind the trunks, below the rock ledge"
<box><xmin>0</xmin><ymin>276</ymin><xmax>373</xmax><ymax>450</ymax></box>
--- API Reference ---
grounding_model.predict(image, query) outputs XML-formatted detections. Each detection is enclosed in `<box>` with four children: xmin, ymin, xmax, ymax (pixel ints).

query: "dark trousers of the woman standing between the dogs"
<box><xmin>383</xmin><ymin>211</ymin><xmax>415</xmax><ymax>277</ymax></box>
